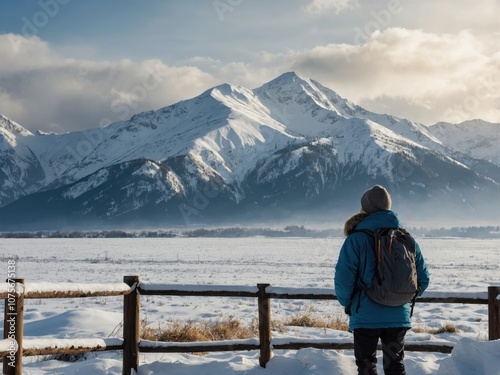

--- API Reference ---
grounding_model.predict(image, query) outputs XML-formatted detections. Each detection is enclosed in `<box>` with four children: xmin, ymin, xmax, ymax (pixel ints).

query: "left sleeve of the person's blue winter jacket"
<box><xmin>334</xmin><ymin>235</ymin><xmax>359</xmax><ymax>307</ymax></box>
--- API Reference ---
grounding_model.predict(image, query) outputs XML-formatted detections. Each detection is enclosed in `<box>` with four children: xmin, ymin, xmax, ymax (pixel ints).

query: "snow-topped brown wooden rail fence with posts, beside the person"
<box><xmin>0</xmin><ymin>276</ymin><xmax>500</xmax><ymax>375</ymax></box>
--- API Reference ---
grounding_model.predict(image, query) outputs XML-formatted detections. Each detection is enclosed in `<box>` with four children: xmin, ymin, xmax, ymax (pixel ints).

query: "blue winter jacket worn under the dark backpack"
<box><xmin>335</xmin><ymin>211</ymin><xmax>429</xmax><ymax>331</ymax></box>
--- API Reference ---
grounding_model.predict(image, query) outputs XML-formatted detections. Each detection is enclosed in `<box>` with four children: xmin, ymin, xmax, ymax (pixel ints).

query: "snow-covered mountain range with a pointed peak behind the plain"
<box><xmin>0</xmin><ymin>72</ymin><xmax>500</xmax><ymax>228</ymax></box>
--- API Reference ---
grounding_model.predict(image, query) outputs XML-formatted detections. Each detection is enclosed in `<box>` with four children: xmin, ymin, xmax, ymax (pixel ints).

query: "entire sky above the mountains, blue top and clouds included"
<box><xmin>0</xmin><ymin>0</ymin><xmax>500</xmax><ymax>132</ymax></box>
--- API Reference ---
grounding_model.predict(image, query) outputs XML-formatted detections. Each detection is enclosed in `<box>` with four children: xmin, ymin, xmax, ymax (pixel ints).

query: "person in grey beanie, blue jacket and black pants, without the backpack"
<box><xmin>335</xmin><ymin>185</ymin><xmax>429</xmax><ymax>375</ymax></box>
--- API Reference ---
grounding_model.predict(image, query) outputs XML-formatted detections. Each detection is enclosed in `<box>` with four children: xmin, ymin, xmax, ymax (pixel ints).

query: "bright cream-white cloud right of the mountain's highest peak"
<box><xmin>289</xmin><ymin>28</ymin><xmax>500</xmax><ymax>123</ymax></box>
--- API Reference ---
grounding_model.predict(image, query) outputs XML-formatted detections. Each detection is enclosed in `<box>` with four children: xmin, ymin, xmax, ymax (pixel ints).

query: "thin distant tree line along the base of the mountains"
<box><xmin>0</xmin><ymin>225</ymin><xmax>500</xmax><ymax>238</ymax></box>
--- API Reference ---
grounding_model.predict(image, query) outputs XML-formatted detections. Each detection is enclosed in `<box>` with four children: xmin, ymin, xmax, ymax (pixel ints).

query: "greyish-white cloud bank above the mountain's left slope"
<box><xmin>0</xmin><ymin>34</ymin><xmax>217</xmax><ymax>132</ymax></box>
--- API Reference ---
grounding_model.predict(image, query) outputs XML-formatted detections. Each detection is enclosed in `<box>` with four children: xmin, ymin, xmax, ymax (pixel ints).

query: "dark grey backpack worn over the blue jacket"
<box><xmin>355</xmin><ymin>228</ymin><xmax>420</xmax><ymax>314</ymax></box>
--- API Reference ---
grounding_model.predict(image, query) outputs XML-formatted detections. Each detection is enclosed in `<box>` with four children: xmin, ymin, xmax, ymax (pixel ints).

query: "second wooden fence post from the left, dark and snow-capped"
<box><xmin>122</xmin><ymin>276</ymin><xmax>141</xmax><ymax>375</ymax></box>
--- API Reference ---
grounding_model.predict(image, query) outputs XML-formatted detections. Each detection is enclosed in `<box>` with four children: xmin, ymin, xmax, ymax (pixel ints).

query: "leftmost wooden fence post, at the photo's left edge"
<box><xmin>3</xmin><ymin>279</ymin><xmax>24</xmax><ymax>375</ymax></box>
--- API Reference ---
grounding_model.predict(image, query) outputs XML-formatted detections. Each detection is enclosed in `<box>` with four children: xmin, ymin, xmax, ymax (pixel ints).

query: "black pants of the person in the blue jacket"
<box><xmin>354</xmin><ymin>328</ymin><xmax>407</xmax><ymax>375</ymax></box>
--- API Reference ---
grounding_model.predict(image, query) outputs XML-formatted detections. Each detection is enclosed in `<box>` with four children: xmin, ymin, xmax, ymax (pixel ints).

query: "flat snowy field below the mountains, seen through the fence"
<box><xmin>0</xmin><ymin>237</ymin><xmax>500</xmax><ymax>375</ymax></box>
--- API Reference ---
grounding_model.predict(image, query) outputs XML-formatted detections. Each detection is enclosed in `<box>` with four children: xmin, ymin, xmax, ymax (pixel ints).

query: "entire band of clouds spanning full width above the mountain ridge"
<box><xmin>0</xmin><ymin>28</ymin><xmax>500</xmax><ymax>132</ymax></box>
